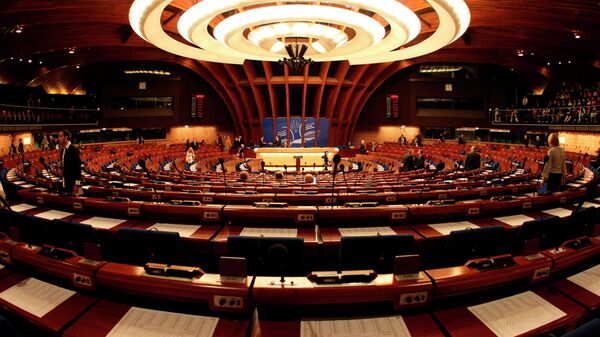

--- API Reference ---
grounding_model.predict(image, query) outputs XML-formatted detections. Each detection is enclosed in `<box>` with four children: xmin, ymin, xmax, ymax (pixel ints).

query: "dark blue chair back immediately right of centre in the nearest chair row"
<box><xmin>339</xmin><ymin>235</ymin><xmax>416</xmax><ymax>273</ymax></box>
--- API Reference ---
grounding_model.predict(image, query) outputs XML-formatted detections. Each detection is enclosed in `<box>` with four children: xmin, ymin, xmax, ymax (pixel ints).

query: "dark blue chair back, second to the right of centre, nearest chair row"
<box><xmin>442</xmin><ymin>226</ymin><xmax>508</xmax><ymax>265</ymax></box>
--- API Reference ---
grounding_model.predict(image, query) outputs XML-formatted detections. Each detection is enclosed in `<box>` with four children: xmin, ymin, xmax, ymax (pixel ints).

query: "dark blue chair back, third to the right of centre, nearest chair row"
<box><xmin>515</xmin><ymin>216</ymin><xmax>565</xmax><ymax>253</ymax></box>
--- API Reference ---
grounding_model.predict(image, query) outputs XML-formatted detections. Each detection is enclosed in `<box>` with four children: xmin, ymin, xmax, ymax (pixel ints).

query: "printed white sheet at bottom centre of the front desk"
<box><xmin>300</xmin><ymin>316</ymin><xmax>410</xmax><ymax>337</ymax></box>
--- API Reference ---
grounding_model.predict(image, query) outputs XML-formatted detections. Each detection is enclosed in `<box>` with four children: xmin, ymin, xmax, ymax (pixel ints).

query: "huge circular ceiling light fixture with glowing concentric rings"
<box><xmin>129</xmin><ymin>0</ymin><xmax>471</xmax><ymax>64</ymax></box>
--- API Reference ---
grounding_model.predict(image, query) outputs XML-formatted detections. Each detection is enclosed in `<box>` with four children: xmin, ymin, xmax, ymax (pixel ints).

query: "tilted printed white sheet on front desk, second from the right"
<box><xmin>467</xmin><ymin>291</ymin><xmax>567</xmax><ymax>337</ymax></box>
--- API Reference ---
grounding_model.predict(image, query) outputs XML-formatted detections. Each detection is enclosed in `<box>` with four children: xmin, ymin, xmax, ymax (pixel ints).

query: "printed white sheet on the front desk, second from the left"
<box><xmin>106</xmin><ymin>307</ymin><xmax>219</xmax><ymax>337</ymax></box>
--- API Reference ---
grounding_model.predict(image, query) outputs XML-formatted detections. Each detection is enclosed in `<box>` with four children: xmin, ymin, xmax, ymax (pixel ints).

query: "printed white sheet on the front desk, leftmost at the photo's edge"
<box><xmin>0</xmin><ymin>277</ymin><xmax>76</xmax><ymax>317</ymax></box>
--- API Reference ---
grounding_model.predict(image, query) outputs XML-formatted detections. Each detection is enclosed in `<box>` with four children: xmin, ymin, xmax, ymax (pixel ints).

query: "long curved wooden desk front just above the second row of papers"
<box><xmin>14</xmin><ymin>186</ymin><xmax>586</xmax><ymax>226</ymax></box>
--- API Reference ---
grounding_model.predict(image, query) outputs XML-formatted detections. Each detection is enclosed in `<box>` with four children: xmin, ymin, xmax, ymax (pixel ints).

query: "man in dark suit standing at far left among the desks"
<box><xmin>58</xmin><ymin>130</ymin><xmax>81</xmax><ymax>193</ymax></box>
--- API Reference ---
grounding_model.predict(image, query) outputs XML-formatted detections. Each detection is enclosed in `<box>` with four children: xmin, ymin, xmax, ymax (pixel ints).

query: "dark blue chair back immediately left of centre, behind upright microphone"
<box><xmin>227</xmin><ymin>235</ymin><xmax>306</xmax><ymax>276</ymax></box>
